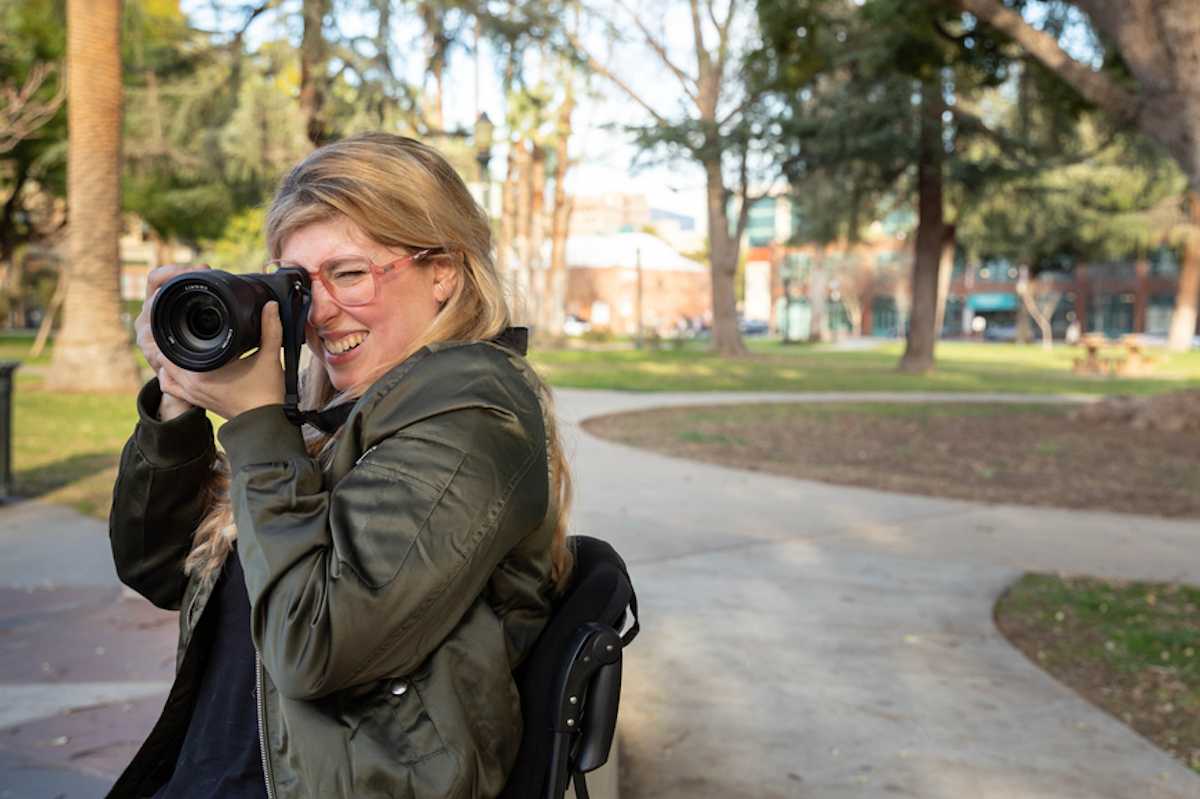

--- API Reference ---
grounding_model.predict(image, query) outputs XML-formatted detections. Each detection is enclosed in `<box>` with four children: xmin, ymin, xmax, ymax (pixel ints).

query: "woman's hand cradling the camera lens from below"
<box><xmin>158</xmin><ymin>302</ymin><xmax>283</xmax><ymax>419</ymax></box>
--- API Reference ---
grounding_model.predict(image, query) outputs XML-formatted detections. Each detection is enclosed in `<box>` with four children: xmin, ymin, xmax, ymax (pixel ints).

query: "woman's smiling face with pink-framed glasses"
<box><xmin>280</xmin><ymin>217</ymin><xmax>454</xmax><ymax>391</ymax></box>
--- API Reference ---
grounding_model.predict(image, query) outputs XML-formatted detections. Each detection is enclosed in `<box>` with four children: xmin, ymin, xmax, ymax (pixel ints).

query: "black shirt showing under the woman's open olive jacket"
<box><xmin>155</xmin><ymin>549</ymin><xmax>266</xmax><ymax>799</ymax></box>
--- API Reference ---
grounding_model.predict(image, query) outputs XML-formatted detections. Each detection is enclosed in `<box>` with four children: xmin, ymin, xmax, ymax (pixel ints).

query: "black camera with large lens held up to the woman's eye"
<box><xmin>150</xmin><ymin>266</ymin><xmax>312</xmax><ymax>372</ymax></box>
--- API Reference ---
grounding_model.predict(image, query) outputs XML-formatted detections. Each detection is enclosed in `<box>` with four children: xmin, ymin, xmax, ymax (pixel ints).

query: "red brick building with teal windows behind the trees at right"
<box><xmin>743</xmin><ymin>197</ymin><xmax>1180</xmax><ymax>337</ymax></box>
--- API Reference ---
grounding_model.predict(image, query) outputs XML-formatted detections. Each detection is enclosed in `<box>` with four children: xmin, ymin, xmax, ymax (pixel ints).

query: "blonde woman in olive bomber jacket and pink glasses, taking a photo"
<box><xmin>110</xmin><ymin>134</ymin><xmax>570</xmax><ymax>799</ymax></box>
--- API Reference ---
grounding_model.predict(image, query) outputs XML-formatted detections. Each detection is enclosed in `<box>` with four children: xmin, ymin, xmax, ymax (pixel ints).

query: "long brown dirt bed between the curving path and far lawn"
<box><xmin>584</xmin><ymin>401</ymin><xmax>1200</xmax><ymax>517</ymax></box>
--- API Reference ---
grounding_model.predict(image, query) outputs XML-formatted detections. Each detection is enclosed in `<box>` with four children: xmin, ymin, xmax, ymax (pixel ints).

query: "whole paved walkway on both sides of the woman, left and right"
<box><xmin>0</xmin><ymin>391</ymin><xmax>1200</xmax><ymax>799</ymax></box>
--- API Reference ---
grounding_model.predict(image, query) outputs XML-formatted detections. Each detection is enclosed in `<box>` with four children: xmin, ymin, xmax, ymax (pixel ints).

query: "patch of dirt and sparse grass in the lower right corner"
<box><xmin>996</xmin><ymin>575</ymin><xmax>1200</xmax><ymax>771</ymax></box>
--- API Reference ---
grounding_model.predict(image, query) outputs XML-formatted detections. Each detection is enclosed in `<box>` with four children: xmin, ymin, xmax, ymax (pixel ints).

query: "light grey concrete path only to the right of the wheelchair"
<box><xmin>558</xmin><ymin>391</ymin><xmax>1200</xmax><ymax>799</ymax></box>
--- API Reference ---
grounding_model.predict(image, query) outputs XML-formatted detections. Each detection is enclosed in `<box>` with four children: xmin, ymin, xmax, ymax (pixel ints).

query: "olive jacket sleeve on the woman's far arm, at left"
<box><xmin>108</xmin><ymin>379</ymin><xmax>216</xmax><ymax>611</ymax></box>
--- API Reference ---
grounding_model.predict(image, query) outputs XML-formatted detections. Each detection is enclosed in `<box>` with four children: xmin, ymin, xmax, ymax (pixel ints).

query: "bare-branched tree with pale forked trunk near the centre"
<box><xmin>571</xmin><ymin>0</ymin><xmax>774</xmax><ymax>356</ymax></box>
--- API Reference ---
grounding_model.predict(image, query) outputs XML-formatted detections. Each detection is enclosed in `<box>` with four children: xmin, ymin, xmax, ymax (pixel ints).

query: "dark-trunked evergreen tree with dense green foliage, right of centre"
<box><xmin>758</xmin><ymin>0</ymin><xmax>1007</xmax><ymax>373</ymax></box>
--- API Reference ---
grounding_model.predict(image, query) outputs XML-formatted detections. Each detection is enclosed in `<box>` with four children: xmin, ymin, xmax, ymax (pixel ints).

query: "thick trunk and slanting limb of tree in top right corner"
<box><xmin>956</xmin><ymin>0</ymin><xmax>1200</xmax><ymax>350</ymax></box>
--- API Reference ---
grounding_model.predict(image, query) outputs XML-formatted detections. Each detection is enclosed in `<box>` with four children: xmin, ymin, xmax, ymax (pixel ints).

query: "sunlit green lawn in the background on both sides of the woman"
<box><xmin>9</xmin><ymin>334</ymin><xmax>1200</xmax><ymax>516</ymax></box>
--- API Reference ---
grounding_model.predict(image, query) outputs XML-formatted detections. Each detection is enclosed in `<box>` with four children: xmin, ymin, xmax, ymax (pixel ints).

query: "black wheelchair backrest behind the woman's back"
<box><xmin>500</xmin><ymin>535</ymin><xmax>640</xmax><ymax>799</ymax></box>
